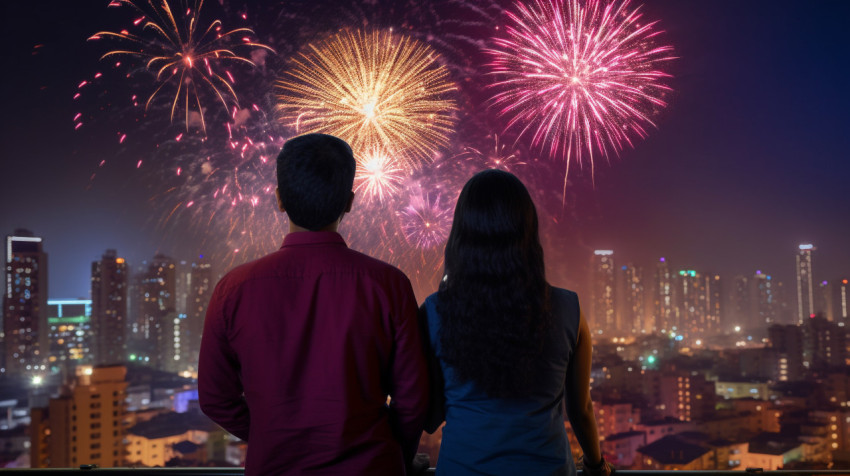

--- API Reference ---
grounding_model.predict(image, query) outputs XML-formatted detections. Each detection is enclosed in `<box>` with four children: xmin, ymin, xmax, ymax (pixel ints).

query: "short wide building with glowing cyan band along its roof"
<box><xmin>47</xmin><ymin>299</ymin><xmax>92</xmax><ymax>370</ymax></box>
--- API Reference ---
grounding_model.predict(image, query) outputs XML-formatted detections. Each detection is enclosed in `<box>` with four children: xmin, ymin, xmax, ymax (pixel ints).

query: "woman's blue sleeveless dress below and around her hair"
<box><xmin>423</xmin><ymin>287</ymin><xmax>579</xmax><ymax>475</ymax></box>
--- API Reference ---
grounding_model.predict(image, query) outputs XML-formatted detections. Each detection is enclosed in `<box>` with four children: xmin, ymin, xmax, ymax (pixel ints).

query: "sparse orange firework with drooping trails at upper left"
<box><xmin>89</xmin><ymin>0</ymin><xmax>273</xmax><ymax>131</ymax></box>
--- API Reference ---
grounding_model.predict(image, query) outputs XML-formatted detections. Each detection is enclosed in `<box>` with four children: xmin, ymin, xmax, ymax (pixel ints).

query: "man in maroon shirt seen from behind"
<box><xmin>198</xmin><ymin>134</ymin><xmax>428</xmax><ymax>476</ymax></box>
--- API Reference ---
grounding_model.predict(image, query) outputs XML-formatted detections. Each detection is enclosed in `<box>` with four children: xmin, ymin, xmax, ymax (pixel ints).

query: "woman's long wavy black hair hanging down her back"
<box><xmin>437</xmin><ymin>170</ymin><xmax>552</xmax><ymax>398</ymax></box>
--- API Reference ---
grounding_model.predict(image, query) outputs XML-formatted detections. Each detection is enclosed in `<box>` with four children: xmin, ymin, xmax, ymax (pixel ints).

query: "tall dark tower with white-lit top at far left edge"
<box><xmin>2</xmin><ymin>229</ymin><xmax>50</xmax><ymax>375</ymax></box>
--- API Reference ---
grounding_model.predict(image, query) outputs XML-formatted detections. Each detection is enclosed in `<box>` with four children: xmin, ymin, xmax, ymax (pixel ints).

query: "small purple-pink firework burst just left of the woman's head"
<box><xmin>399</xmin><ymin>194</ymin><xmax>452</xmax><ymax>249</ymax></box>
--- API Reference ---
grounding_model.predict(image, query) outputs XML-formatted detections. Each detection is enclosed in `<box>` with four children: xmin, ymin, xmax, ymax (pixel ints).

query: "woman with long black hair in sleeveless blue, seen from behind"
<box><xmin>420</xmin><ymin>170</ymin><xmax>610</xmax><ymax>475</ymax></box>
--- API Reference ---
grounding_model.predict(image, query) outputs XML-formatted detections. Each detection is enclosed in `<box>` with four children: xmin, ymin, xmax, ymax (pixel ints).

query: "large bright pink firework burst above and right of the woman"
<box><xmin>487</xmin><ymin>0</ymin><xmax>674</xmax><ymax>177</ymax></box>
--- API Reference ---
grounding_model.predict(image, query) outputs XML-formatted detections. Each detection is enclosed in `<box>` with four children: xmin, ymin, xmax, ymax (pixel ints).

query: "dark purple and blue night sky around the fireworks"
<box><xmin>0</xmin><ymin>0</ymin><xmax>850</xmax><ymax>303</ymax></box>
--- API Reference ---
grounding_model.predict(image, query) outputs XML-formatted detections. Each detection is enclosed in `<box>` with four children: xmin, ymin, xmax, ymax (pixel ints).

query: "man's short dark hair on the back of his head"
<box><xmin>277</xmin><ymin>134</ymin><xmax>355</xmax><ymax>231</ymax></box>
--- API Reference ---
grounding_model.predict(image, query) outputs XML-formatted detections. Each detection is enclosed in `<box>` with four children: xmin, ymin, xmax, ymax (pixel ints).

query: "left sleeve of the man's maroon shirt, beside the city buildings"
<box><xmin>198</xmin><ymin>281</ymin><xmax>251</xmax><ymax>441</ymax></box>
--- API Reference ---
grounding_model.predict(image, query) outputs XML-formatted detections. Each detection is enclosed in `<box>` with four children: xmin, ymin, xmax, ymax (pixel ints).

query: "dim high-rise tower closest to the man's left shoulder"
<box><xmin>183</xmin><ymin>256</ymin><xmax>215</xmax><ymax>369</ymax></box>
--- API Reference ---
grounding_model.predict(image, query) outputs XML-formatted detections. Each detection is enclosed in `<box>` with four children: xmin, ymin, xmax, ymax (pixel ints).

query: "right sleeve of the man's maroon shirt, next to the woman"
<box><xmin>390</xmin><ymin>278</ymin><xmax>429</xmax><ymax>465</ymax></box>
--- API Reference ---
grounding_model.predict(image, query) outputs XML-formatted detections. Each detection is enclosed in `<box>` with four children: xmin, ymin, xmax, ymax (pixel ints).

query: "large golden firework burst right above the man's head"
<box><xmin>277</xmin><ymin>30</ymin><xmax>455</xmax><ymax>164</ymax></box>
